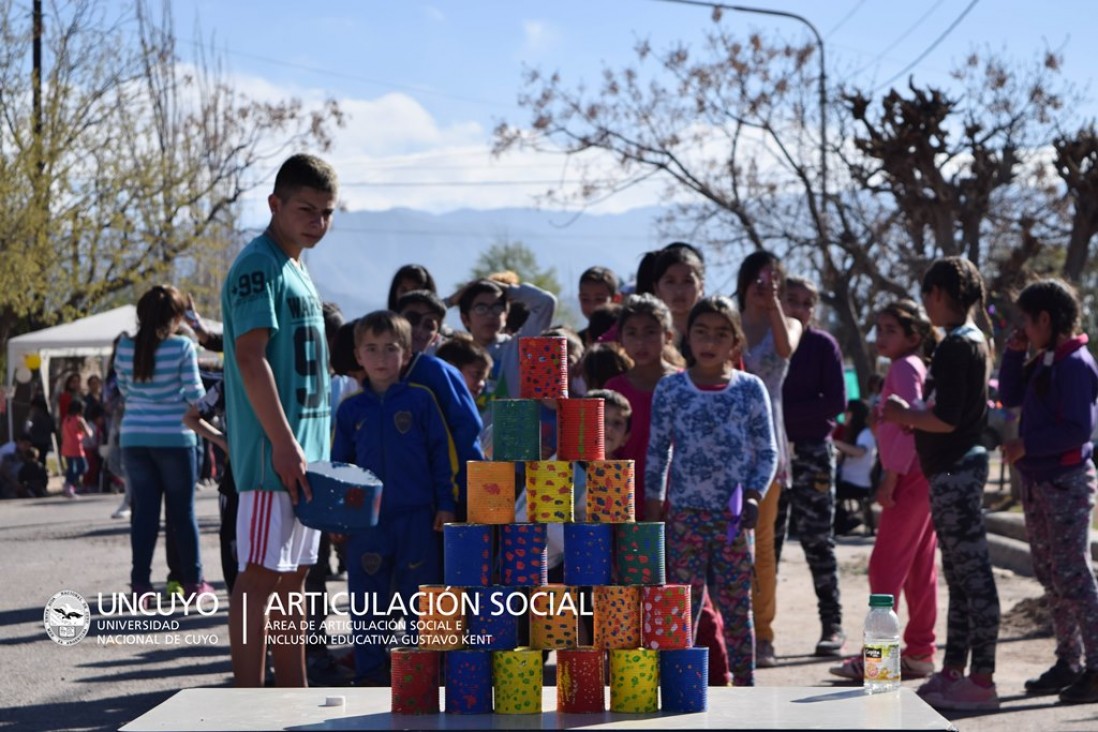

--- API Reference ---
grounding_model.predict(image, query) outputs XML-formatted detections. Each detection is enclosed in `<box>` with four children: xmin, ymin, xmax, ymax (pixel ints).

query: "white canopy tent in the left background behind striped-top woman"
<box><xmin>5</xmin><ymin>305</ymin><xmax>221</xmax><ymax>399</ymax></box>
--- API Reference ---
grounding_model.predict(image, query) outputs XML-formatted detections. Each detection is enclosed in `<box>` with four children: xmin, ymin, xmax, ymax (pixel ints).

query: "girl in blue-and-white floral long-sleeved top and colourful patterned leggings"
<box><xmin>645</xmin><ymin>297</ymin><xmax>777</xmax><ymax>686</ymax></box>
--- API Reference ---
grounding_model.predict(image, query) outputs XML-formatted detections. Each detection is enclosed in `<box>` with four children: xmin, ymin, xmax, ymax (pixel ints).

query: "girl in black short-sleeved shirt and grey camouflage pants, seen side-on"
<box><xmin>882</xmin><ymin>257</ymin><xmax>999</xmax><ymax>711</ymax></box>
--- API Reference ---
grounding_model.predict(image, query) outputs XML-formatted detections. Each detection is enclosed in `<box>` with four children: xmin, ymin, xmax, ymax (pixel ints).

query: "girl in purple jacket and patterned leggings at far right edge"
<box><xmin>999</xmin><ymin>280</ymin><xmax>1098</xmax><ymax>703</ymax></box>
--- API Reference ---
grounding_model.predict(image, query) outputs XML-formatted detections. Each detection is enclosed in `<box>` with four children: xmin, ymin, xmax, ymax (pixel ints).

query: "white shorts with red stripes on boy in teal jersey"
<box><xmin>236</xmin><ymin>491</ymin><xmax>321</xmax><ymax>572</ymax></box>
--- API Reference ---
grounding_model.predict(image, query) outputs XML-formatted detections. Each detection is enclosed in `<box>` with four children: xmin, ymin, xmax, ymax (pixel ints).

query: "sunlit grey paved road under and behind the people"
<box><xmin>0</xmin><ymin>482</ymin><xmax>1098</xmax><ymax>732</ymax></box>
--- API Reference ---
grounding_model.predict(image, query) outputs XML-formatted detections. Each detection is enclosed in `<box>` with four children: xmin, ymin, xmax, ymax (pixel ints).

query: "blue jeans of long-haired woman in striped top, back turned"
<box><xmin>122</xmin><ymin>447</ymin><xmax>203</xmax><ymax>587</ymax></box>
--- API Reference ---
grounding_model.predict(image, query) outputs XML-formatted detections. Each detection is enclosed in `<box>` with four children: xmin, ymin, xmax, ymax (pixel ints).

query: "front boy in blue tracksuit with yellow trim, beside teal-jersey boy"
<box><xmin>332</xmin><ymin>311</ymin><xmax>457</xmax><ymax>686</ymax></box>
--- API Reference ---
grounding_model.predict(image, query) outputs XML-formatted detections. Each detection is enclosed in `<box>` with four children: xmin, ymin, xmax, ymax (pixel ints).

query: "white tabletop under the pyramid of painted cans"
<box><xmin>122</xmin><ymin>686</ymin><xmax>956</xmax><ymax>732</ymax></box>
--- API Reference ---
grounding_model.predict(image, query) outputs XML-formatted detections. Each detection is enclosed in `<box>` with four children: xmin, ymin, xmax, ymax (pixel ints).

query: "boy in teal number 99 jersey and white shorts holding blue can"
<box><xmin>221</xmin><ymin>155</ymin><xmax>338</xmax><ymax>687</ymax></box>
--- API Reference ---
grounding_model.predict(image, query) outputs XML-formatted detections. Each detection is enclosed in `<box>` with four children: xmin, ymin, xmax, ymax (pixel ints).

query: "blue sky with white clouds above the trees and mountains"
<box><xmin>159</xmin><ymin>0</ymin><xmax>1098</xmax><ymax>219</ymax></box>
